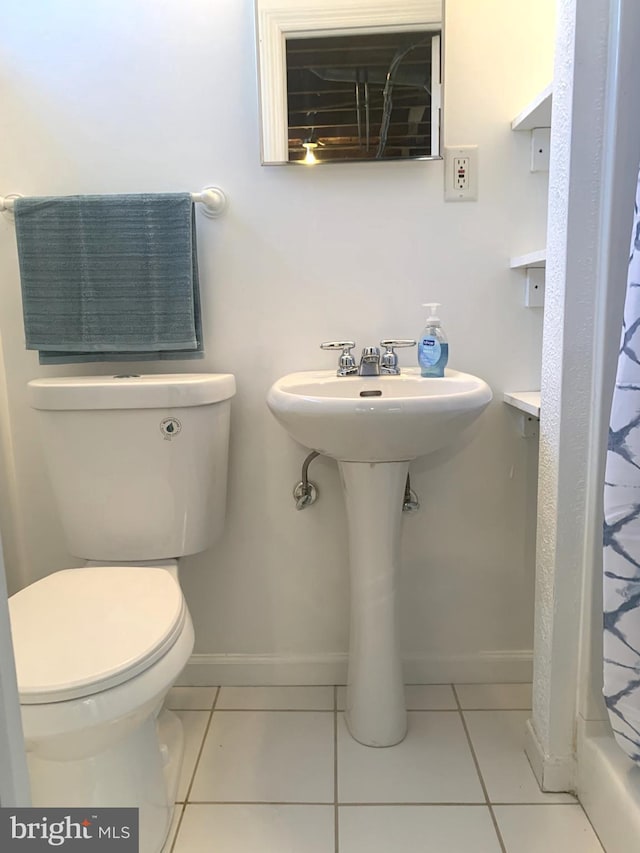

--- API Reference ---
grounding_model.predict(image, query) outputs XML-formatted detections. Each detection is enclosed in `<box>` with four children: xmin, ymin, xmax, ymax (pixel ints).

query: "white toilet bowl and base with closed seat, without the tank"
<box><xmin>9</xmin><ymin>563</ymin><xmax>194</xmax><ymax>853</ymax></box>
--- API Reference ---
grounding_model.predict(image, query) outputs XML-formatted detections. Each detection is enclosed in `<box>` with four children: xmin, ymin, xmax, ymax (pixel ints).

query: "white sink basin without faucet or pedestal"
<box><xmin>267</xmin><ymin>368</ymin><xmax>492</xmax><ymax>462</ymax></box>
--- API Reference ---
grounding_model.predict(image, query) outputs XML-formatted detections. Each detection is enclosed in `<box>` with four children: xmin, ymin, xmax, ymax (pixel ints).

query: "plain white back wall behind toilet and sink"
<box><xmin>0</xmin><ymin>0</ymin><xmax>554</xmax><ymax>679</ymax></box>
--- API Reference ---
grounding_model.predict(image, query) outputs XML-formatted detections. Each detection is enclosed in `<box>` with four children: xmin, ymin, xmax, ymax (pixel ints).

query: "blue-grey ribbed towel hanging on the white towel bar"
<box><xmin>14</xmin><ymin>193</ymin><xmax>203</xmax><ymax>364</ymax></box>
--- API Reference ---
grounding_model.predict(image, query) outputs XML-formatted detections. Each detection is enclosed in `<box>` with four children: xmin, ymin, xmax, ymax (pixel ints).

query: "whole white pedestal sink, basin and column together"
<box><xmin>267</xmin><ymin>369</ymin><xmax>492</xmax><ymax>746</ymax></box>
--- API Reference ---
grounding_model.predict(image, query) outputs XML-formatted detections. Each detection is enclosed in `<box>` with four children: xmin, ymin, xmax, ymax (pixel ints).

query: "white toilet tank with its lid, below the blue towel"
<box><xmin>29</xmin><ymin>373</ymin><xmax>235</xmax><ymax>562</ymax></box>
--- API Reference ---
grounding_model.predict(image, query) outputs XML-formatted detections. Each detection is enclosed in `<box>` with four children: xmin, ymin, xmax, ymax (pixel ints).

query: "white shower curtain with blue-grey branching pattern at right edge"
<box><xmin>603</xmin><ymin>163</ymin><xmax>640</xmax><ymax>764</ymax></box>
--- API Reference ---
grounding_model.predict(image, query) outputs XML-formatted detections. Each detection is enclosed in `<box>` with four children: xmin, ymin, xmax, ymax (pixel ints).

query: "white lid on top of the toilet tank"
<box><xmin>28</xmin><ymin>373</ymin><xmax>236</xmax><ymax>410</ymax></box>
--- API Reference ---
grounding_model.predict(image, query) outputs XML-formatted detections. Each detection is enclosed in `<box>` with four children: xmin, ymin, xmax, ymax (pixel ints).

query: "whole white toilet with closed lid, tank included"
<box><xmin>9</xmin><ymin>373</ymin><xmax>235</xmax><ymax>853</ymax></box>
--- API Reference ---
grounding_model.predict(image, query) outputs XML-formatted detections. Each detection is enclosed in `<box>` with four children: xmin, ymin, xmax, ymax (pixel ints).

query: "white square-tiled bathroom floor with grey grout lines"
<box><xmin>164</xmin><ymin>684</ymin><xmax>603</xmax><ymax>853</ymax></box>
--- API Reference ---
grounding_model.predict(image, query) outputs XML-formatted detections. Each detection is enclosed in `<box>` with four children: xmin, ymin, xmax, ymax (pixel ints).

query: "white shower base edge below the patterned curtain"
<box><xmin>578</xmin><ymin>718</ymin><xmax>640</xmax><ymax>853</ymax></box>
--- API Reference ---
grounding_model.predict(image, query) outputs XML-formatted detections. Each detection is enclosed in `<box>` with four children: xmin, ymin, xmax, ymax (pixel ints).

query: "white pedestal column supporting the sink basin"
<box><xmin>338</xmin><ymin>462</ymin><xmax>409</xmax><ymax>746</ymax></box>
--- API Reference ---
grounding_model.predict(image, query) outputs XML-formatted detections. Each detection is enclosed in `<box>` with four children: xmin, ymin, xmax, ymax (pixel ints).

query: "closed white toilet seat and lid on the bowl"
<box><xmin>9</xmin><ymin>566</ymin><xmax>187</xmax><ymax>705</ymax></box>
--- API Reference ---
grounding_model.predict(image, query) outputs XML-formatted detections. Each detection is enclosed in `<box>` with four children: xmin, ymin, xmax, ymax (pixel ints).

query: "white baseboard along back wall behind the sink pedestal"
<box><xmin>177</xmin><ymin>650</ymin><xmax>533</xmax><ymax>686</ymax></box>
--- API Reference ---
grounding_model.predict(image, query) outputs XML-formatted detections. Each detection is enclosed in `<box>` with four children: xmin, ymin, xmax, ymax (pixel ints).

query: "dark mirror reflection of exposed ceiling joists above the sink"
<box><xmin>286</xmin><ymin>30</ymin><xmax>439</xmax><ymax>161</ymax></box>
